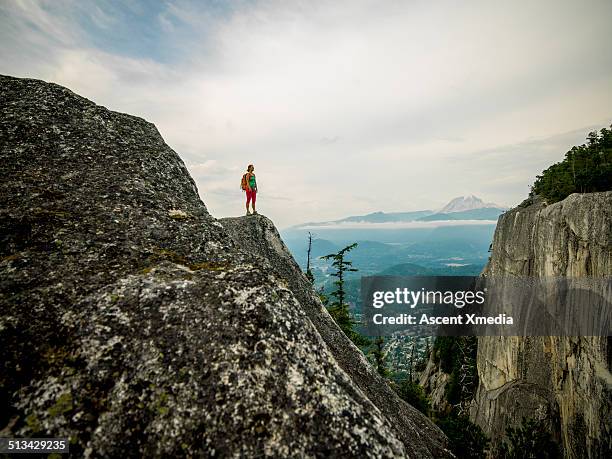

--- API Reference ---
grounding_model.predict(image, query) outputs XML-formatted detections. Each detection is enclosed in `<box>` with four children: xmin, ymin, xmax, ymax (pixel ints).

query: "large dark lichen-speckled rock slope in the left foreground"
<box><xmin>0</xmin><ymin>76</ymin><xmax>446</xmax><ymax>457</ymax></box>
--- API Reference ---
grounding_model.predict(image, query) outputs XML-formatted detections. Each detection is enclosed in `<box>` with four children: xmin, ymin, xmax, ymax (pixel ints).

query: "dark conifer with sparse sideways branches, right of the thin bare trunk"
<box><xmin>321</xmin><ymin>242</ymin><xmax>370</xmax><ymax>346</ymax></box>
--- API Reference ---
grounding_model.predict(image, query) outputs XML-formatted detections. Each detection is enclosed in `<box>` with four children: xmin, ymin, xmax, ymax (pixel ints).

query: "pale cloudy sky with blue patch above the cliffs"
<box><xmin>0</xmin><ymin>0</ymin><xmax>612</xmax><ymax>228</ymax></box>
